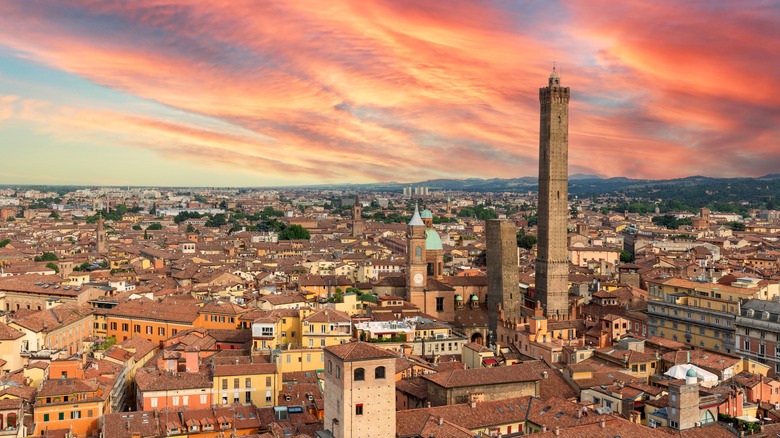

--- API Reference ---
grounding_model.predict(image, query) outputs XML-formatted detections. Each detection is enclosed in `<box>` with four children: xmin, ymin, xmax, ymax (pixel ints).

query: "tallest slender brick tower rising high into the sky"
<box><xmin>536</xmin><ymin>68</ymin><xmax>569</xmax><ymax>318</ymax></box>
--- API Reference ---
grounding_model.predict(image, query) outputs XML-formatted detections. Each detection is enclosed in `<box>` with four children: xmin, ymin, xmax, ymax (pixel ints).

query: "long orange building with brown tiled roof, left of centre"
<box><xmin>106</xmin><ymin>296</ymin><xmax>199</xmax><ymax>345</ymax></box>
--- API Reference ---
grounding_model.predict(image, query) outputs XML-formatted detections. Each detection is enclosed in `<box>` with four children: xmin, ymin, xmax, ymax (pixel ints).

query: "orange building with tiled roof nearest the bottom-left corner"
<box><xmin>32</xmin><ymin>378</ymin><xmax>109</xmax><ymax>438</ymax></box>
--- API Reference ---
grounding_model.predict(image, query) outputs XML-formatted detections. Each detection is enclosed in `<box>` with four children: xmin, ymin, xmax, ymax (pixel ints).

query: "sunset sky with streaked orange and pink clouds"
<box><xmin>0</xmin><ymin>0</ymin><xmax>780</xmax><ymax>186</ymax></box>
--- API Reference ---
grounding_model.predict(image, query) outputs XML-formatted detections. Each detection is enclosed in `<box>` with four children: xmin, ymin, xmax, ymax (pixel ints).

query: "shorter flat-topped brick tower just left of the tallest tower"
<box><xmin>485</xmin><ymin>219</ymin><xmax>520</xmax><ymax>343</ymax></box>
